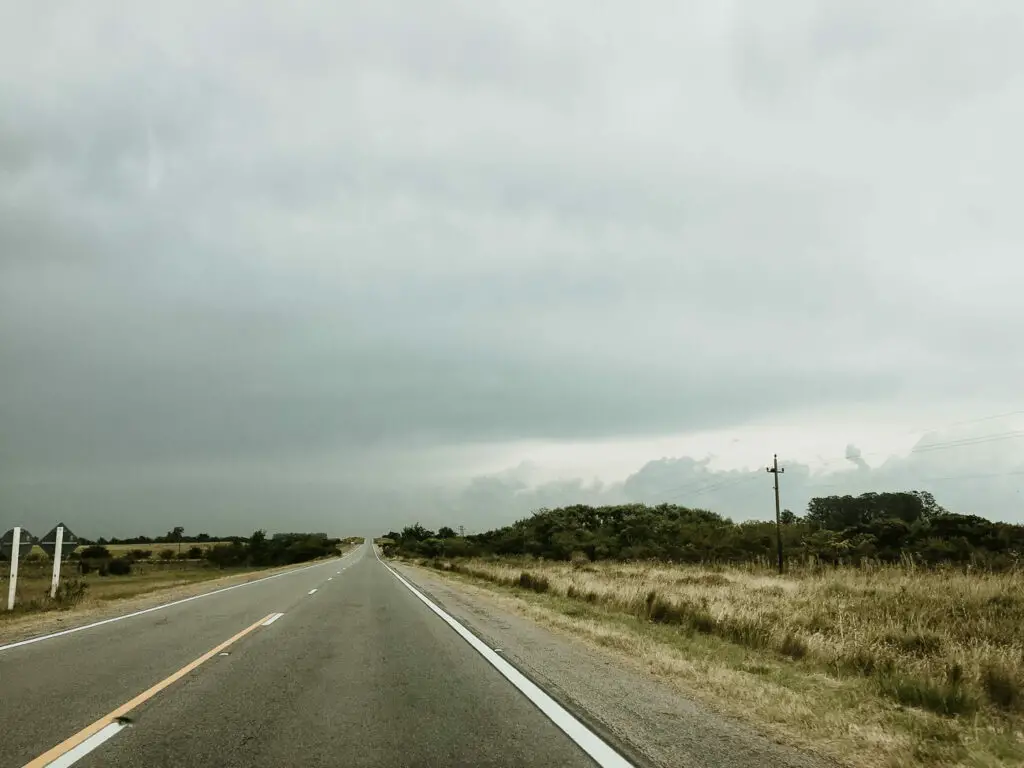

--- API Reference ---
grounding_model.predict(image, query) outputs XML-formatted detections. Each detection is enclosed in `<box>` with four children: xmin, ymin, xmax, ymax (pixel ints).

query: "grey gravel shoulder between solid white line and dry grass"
<box><xmin>390</xmin><ymin>562</ymin><xmax>835</xmax><ymax>768</ymax></box>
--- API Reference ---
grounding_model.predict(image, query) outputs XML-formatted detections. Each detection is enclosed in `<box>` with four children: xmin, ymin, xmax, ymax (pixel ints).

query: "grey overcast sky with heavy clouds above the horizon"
<box><xmin>0</xmin><ymin>0</ymin><xmax>1024</xmax><ymax>536</ymax></box>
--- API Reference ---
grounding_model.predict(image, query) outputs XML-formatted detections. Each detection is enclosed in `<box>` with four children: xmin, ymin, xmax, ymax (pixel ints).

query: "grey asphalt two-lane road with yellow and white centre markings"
<box><xmin>0</xmin><ymin>543</ymin><xmax>625</xmax><ymax>768</ymax></box>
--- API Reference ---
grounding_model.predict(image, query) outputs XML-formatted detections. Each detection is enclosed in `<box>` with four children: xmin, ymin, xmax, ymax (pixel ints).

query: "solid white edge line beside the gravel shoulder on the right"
<box><xmin>374</xmin><ymin>547</ymin><xmax>633</xmax><ymax>768</ymax></box>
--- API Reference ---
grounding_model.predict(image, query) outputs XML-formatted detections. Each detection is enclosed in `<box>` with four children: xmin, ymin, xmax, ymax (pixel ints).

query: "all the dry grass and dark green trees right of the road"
<box><xmin>379</xmin><ymin>494</ymin><xmax>1024</xmax><ymax>767</ymax></box>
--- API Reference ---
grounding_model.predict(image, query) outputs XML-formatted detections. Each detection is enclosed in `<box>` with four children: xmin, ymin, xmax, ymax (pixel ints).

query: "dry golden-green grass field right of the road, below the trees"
<box><xmin>420</xmin><ymin>559</ymin><xmax>1024</xmax><ymax>768</ymax></box>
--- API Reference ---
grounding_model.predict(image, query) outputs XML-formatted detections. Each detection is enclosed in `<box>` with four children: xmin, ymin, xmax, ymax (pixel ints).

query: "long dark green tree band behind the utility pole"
<box><xmin>384</xmin><ymin>490</ymin><xmax>1024</xmax><ymax>568</ymax></box>
